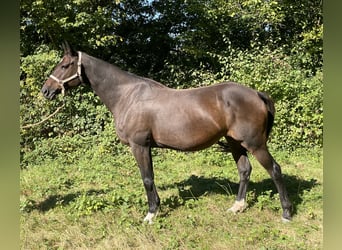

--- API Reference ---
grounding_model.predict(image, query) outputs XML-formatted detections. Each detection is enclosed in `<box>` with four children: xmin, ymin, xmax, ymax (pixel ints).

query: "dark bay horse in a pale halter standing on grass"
<box><xmin>41</xmin><ymin>44</ymin><xmax>292</xmax><ymax>223</ymax></box>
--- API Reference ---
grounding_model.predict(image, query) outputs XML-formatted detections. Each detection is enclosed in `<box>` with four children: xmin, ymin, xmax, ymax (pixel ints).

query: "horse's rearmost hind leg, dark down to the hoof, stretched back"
<box><xmin>253</xmin><ymin>145</ymin><xmax>292</xmax><ymax>221</ymax></box>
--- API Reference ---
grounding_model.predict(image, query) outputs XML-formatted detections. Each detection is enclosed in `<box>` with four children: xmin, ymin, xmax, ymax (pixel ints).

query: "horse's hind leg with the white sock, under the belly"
<box><xmin>227</xmin><ymin>138</ymin><xmax>252</xmax><ymax>213</ymax></box>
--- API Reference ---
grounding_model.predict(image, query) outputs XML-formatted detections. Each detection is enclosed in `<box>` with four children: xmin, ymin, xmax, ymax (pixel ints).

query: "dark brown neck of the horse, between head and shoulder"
<box><xmin>82</xmin><ymin>55</ymin><xmax>136</xmax><ymax>115</ymax></box>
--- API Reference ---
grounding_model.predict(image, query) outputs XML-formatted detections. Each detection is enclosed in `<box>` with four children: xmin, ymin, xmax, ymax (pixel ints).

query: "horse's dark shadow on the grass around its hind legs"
<box><xmin>159</xmin><ymin>175</ymin><xmax>321</xmax><ymax>215</ymax></box>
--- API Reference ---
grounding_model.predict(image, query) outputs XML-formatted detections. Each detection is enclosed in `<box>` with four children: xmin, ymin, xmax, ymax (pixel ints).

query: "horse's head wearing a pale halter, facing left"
<box><xmin>41</xmin><ymin>43</ymin><xmax>82</xmax><ymax>99</ymax></box>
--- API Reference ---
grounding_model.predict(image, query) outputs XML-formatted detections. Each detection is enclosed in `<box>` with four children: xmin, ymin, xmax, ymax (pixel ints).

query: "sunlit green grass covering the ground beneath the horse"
<box><xmin>20</xmin><ymin>142</ymin><xmax>323</xmax><ymax>249</ymax></box>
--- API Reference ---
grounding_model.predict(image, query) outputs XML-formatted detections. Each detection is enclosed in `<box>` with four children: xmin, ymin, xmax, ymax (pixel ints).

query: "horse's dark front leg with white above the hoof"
<box><xmin>131</xmin><ymin>144</ymin><xmax>160</xmax><ymax>224</ymax></box>
